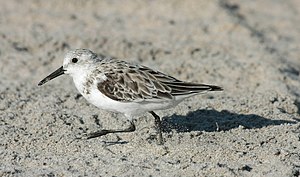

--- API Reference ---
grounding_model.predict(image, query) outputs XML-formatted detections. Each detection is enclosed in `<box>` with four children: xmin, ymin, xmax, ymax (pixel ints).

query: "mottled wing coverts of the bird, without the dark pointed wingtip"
<box><xmin>98</xmin><ymin>66</ymin><xmax>173</xmax><ymax>102</ymax></box>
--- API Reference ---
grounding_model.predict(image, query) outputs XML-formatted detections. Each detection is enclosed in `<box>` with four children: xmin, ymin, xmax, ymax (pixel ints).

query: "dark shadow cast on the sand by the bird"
<box><xmin>162</xmin><ymin>109</ymin><xmax>299</xmax><ymax>132</ymax></box>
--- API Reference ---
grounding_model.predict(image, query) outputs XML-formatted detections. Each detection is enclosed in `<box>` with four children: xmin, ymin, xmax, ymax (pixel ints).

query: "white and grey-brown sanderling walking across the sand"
<box><xmin>38</xmin><ymin>49</ymin><xmax>223</xmax><ymax>144</ymax></box>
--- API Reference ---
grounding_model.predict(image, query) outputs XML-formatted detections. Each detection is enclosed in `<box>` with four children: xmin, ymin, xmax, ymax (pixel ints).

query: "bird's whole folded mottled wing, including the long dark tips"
<box><xmin>98</xmin><ymin>63</ymin><xmax>221</xmax><ymax>102</ymax></box>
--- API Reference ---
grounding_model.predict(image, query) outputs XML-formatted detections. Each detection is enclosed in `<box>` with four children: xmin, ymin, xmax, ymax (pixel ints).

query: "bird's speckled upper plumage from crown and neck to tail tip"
<box><xmin>66</xmin><ymin>49</ymin><xmax>221</xmax><ymax>102</ymax></box>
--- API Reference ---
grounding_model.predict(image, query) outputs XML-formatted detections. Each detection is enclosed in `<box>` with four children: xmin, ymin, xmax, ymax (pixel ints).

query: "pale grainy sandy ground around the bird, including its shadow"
<box><xmin>0</xmin><ymin>0</ymin><xmax>300</xmax><ymax>177</ymax></box>
